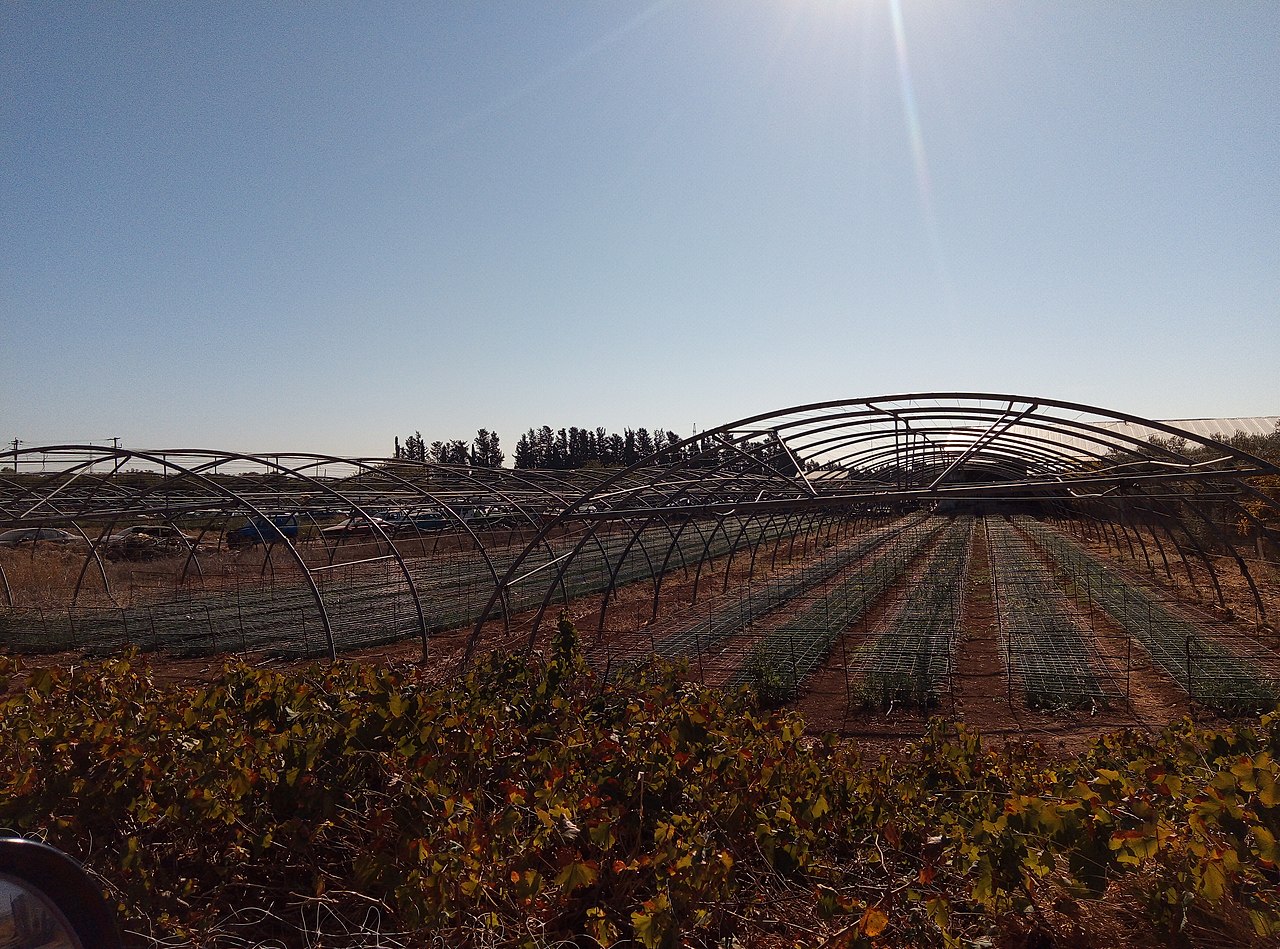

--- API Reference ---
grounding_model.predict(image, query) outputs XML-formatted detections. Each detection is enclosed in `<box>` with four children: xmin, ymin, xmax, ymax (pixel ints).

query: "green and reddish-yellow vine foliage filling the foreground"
<box><xmin>0</xmin><ymin>622</ymin><xmax>1280</xmax><ymax>948</ymax></box>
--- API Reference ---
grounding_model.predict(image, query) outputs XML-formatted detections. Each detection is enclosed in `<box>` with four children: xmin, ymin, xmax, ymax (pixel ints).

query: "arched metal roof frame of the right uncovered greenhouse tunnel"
<box><xmin>465</xmin><ymin>392</ymin><xmax>1277</xmax><ymax>655</ymax></box>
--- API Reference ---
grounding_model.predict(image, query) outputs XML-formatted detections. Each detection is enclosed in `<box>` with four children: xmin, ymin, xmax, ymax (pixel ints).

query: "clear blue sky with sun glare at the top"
<box><xmin>0</xmin><ymin>0</ymin><xmax>1280</xmax><ymax>456</ymax></box>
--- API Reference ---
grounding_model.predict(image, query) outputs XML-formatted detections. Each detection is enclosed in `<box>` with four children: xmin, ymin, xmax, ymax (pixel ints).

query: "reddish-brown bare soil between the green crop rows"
<box><xmin>4</xmin><ymin>514</ymin><xmax>1280</xmax><ymax>754</ymax></box>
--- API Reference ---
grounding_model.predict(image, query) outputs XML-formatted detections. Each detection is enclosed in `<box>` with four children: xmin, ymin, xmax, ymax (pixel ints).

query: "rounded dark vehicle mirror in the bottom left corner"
<box><xmin>0</xmin><ymin>838</ymin><xmax>120</xmax><ymax>949</ymax></box>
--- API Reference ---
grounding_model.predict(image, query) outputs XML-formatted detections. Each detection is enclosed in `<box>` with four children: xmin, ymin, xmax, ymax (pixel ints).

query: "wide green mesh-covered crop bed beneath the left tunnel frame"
<box><xmin>0</xmin><ymin>519</ymin><xmax>794</xmax><ymax>654</ymax></box>
